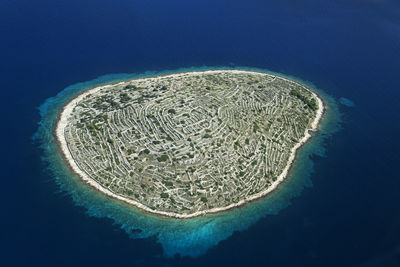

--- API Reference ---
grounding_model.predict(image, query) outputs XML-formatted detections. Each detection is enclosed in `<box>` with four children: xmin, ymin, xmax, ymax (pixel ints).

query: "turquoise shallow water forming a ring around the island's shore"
<box><xmin>34</xmin><ymin>67</ymin><xmax>341</xmax><ymax>257</ymax></box>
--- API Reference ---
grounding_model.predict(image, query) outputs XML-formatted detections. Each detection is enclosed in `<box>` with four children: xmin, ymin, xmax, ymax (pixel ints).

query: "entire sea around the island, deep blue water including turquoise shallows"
<box><xmin>0</xmin><ymin>0</ymin><xmax>400</xmax><ymax>267</ymax></box>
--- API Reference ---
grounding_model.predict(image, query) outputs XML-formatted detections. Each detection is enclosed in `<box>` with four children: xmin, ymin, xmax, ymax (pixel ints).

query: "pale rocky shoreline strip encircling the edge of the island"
<box><xmin>54</xmin><ymin>70</ymin><xmax>326</xmax><ymax>219</ymax></box>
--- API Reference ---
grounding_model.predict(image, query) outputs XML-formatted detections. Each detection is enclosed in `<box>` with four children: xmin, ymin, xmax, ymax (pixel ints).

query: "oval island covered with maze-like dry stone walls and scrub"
<box><xmin>55</xmin><ymin>70</ymin><xmax>325</xmax><ymax>218</ymax></box>
